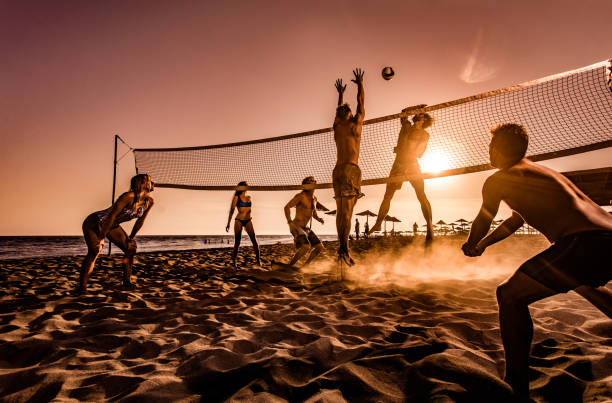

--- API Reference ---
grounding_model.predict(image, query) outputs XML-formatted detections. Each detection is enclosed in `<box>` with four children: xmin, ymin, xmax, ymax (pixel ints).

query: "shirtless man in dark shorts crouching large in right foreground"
<box><xmin>462</xmin><ymin>123</ymin><xmax>612</xmax><ymax>398</ymax></box>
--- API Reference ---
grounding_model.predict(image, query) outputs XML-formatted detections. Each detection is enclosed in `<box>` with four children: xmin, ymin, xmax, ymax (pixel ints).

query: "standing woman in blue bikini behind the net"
<box><xmin>225</xmin><ymin>181</ymin><xmax>261</xmax><ymax>268</ymax></box>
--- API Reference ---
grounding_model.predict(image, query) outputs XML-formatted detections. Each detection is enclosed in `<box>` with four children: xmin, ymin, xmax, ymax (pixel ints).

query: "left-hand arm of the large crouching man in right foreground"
<box><xmin>461</xmin><ymin>176</ymin><xmax>501</xmax><ymax>256</ymax></box>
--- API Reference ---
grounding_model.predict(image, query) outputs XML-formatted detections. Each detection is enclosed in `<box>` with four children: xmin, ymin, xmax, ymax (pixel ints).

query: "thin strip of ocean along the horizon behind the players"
<box><xmin>0</xmin><ymin>235</ymin><xmax>337</xmax><ymax>260</ymax></box>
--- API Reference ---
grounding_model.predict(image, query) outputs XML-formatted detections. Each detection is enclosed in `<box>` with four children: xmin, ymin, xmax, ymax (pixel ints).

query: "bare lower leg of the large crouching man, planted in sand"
<box><xmin>497</xmin><ymin>270</ymin><xmax>557</xmax><ymax>397</ymax></box>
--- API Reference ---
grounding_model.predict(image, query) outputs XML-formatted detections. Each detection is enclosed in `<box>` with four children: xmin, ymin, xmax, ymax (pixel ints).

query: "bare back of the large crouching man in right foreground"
<box><xmin>483</xmin><ymin>159</ymin><xmax>612</xmax><ymax>242</ymax></box>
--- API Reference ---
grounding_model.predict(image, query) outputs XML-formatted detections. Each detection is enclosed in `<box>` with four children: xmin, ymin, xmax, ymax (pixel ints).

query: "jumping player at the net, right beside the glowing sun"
<box><xmin>370</xmin><ymin>105</ymin><xmax>434</xmax><ymax>241</ymax></box>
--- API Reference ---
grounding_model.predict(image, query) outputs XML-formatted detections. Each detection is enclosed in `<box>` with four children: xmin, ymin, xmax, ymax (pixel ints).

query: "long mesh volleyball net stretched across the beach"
<box><xmin>134</xmin><ymin>61</ymin><xmax>612</xmax><ymax>190</ymax></box>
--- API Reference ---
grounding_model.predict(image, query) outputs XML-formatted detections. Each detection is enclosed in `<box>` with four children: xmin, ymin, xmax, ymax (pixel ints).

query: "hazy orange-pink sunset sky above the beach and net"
<box><xmin>0</xmin><ymin>0</ymin><xmax>612</xmax><ymax>235</ymax></box>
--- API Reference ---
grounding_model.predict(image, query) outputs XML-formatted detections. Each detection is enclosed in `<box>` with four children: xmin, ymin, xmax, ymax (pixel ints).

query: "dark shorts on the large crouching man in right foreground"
<box><xmin>519</xmin><ymin>230</ymin><xmax>612</xmax><ymax>293</ymax></box>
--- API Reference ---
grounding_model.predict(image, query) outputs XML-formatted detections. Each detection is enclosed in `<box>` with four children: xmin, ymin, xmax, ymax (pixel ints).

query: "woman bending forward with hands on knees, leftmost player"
<box><xmin>77</xmin><ymin>174</ymin><xmax>153</xmax><ymax>294</ymax></box>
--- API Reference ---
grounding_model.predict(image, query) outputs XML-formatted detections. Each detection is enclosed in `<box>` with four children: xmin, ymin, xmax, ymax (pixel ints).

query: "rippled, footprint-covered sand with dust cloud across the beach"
<box><xmin>0</xmin><ymin>237</ymin><xmax>612</xmax><ymax>402</ymax></box>
